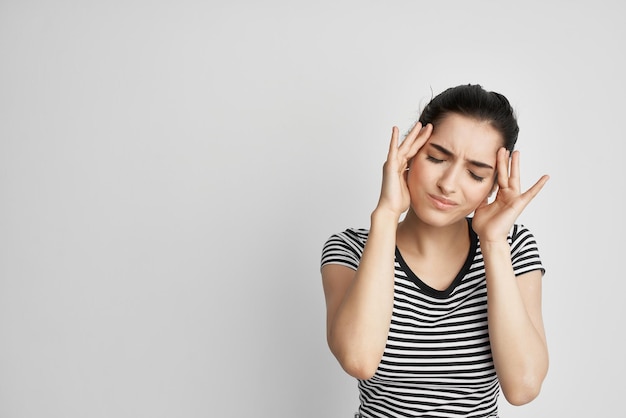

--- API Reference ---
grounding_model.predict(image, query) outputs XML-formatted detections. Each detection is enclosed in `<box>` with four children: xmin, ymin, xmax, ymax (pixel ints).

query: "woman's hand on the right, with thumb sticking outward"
<box><xmin>472</xmin><ymin>148</ymin><xmax>549</xmax><ymax>243</ymax></box>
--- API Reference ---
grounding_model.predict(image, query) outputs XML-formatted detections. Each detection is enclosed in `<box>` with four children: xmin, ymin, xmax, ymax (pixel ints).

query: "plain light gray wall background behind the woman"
<box><xmin>0</xmin><ymin>0</ymin><xmax>626</xmax><ymax>418</ymax></box>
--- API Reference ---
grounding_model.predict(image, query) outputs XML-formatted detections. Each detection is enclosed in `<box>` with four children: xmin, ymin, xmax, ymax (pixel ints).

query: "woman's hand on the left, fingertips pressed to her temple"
<box><xmin>376</xmin><ymin>122</ymin><xmax>433</xmax><ymax>217</ymax></box>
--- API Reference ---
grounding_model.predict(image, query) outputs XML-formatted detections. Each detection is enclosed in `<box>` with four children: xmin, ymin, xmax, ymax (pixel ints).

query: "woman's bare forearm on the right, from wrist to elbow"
<box><xmin>481</xmin><ymin>240</ymin><xmax>548</xmax><ymax>404</ymax></box>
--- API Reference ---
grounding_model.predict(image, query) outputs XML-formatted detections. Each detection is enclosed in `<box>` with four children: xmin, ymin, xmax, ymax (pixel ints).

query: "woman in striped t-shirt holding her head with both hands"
<box><xmin>321</xmin><ymin>85</ymin><xmax>548</xmax><ymax>418</ymax></box>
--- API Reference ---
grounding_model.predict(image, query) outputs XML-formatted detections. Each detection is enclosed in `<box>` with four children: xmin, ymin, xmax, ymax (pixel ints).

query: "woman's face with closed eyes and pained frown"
<box><xmin>407</xmin><ymin>113</ymin><xmax>504</xmax><ymax>226</ymax></box>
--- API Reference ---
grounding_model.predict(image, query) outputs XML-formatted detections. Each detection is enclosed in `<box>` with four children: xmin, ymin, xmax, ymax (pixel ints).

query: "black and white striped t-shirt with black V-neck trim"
<box><xmin>321</xmin><ymin>218</ymin><xmax>544</xmax><ymax>418</ymax></box>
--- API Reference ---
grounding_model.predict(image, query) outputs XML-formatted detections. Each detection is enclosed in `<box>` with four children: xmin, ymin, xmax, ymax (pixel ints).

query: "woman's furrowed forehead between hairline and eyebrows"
<box><xmin>428</xmin><ymin>113</ymin><xmax>504</xmax><ymax>159</ymax></box>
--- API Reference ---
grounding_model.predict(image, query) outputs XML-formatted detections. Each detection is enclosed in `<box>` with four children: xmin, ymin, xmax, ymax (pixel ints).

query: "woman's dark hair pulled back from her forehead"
<box><xmin>419</xmin><ymin>84</ymin><xmax>519</xmax><ymax>151</ymax></box>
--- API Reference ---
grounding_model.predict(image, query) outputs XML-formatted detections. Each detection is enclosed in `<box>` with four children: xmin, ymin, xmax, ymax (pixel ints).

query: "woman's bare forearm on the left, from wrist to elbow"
<box><xmin>329</xmin><ymin>211</ymin><xmax>398</xmax><ymax>378</ymax></box>
